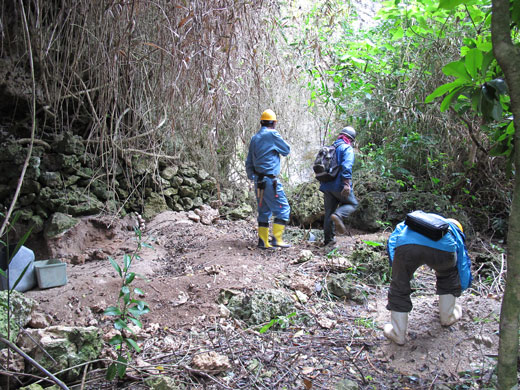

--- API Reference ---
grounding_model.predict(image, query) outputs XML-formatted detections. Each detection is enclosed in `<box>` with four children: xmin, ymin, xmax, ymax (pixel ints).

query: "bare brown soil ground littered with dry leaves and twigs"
<box><xmin>22</xmin><ymin>212</ymin><xmax>500</xmax><ymax>389</ymax></box>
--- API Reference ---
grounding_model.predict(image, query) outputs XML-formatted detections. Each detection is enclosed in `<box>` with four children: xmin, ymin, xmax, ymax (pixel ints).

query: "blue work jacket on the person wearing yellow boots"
<box><xmin>246</xmin><ymin>126</ymin><xmax>291</xmax><ymax>180</ymax></box>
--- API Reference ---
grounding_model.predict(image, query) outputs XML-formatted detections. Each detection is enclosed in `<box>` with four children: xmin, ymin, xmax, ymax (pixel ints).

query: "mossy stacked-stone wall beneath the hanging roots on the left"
<box><xmin>0</xmin><ymin>132</ymin><xmax>223</xmax><ymax>235</ymax></box>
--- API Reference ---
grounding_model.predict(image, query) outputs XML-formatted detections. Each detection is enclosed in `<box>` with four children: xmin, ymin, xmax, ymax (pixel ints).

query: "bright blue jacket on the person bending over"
<box><xmin>387</xmin><ymin>220</ymin><xmax>473</xmax><ymax>290</ymax></box>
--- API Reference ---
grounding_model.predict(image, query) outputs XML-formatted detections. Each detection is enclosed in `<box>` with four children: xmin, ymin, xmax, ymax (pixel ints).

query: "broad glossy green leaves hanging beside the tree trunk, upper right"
<box><xmin>425</xmin><ymin>0</ymin><xmax>519</xmax><ymax>165</ymax></box>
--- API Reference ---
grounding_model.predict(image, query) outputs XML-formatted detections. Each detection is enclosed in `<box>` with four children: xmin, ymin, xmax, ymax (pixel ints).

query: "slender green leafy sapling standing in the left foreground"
<box><xmin>105</xmin><ymin>227</ymin><xmax>151</xmax><ymax>380</ymax></box>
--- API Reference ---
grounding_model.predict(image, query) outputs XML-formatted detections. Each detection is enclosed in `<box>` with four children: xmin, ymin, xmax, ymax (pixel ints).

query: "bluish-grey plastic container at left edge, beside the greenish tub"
<box><xmin>0</xmin><ymin>245</ymin><xmax>36</xmax><ymax>292</ymax></box>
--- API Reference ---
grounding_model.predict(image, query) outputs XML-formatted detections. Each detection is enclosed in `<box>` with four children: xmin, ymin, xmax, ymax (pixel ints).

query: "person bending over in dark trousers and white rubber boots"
<box><xmin>383</xmin><ymin>216</ymin><xmax>472</xmax><ymax>345</ymax></box>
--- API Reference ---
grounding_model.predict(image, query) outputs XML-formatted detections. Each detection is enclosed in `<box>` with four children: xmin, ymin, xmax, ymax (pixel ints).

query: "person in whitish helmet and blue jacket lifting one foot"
<box><xmin>320</xmin><ymin>126</ymin><xmax>358</xmax><ymax>246</ymax></box>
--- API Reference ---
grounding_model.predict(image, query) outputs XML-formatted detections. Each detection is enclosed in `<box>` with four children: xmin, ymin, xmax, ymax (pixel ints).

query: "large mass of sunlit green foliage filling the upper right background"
<box><xmin>284</xmin><ymin>0</ymin><xmax>520</xmax><ymax>236</ymax></box>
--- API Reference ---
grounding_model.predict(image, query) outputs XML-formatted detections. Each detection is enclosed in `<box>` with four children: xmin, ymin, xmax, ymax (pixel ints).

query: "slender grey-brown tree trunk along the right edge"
<box><xmin>491</xmin><ymin>0</ymin><xmax>520</xmax><ymax>390</ymax></box>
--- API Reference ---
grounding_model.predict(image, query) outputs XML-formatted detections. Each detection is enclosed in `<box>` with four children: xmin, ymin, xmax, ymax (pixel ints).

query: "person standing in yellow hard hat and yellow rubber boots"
<box><xmin>246</xmin><ymin>110</ymin><xmax>291</xmax><ymax>249</ymax></box>
